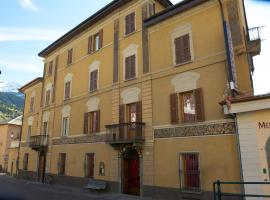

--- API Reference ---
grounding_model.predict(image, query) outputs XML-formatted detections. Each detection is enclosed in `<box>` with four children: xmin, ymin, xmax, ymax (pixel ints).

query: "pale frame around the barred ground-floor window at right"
<box><xmin>178</xmin><ymin>151</ymin><xmax>202</xmax><ymax>192</ymax></box>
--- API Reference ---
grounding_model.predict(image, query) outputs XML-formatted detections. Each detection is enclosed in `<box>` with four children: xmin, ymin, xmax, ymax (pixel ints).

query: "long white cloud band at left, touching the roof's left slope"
<box><xmin>0</xmin><ymin>27</ymin><xmax>65</xmax><ymax>42</ymax></box>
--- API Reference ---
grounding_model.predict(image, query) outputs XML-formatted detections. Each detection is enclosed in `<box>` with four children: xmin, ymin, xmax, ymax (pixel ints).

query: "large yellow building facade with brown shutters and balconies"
<box><xmin>19</xmin><ymin>0</ymin><xmax>262</xmax><ymax>199</ymax></box>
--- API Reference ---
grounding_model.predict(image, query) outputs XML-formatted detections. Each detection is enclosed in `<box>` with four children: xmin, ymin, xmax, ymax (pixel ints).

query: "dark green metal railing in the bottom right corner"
<box><xmin>213</xmin><ymin>180</ymin><xmax>270</xmax><ymax>200</ymax></box>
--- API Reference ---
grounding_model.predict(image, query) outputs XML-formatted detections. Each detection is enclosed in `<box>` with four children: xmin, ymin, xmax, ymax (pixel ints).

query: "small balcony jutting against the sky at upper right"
<box><xmin>247</xmin><ymin>27</ymin><xmax>262</xmax><ymax>57</ymax></box>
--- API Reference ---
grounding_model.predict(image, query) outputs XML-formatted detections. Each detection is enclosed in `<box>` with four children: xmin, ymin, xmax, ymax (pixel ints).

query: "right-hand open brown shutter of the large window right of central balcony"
<box><xmin>194</xmin><ymin>88</ymin><xmax>205</xmax><ymax>121</ymax></box>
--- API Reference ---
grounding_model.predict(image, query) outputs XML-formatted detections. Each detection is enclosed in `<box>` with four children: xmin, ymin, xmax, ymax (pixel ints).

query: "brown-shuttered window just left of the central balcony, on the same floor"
<box><xmin>84</xmin><ymin>110</ymin><xmax>100</xmax><ymax>134</ymax></box>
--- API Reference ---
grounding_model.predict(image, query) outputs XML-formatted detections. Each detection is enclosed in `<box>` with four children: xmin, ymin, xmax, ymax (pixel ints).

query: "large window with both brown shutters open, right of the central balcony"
<box><xmin>170</xmin><ymin>88</ymin><xmax>204</xmax><ymax>124</ymax></box>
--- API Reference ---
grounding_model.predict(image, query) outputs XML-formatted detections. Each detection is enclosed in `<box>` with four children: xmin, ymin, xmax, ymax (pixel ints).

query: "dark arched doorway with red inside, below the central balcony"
<box><xmin>122</xmin><ymin>148</ymin><xmax>140</xmax><ymax>195</ymax></box>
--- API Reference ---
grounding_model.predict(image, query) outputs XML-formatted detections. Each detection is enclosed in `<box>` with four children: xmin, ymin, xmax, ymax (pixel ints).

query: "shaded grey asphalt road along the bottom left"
<box><xmin>0</xmin><ymin>175</ymin><xmax>150</xmax><ymax>200</ymax></box>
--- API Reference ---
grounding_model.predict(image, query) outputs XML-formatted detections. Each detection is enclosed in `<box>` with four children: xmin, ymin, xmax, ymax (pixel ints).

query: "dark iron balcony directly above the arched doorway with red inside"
<box><xmin>105</xmin><ymin>122</ymin><xmax>145</xmax><ymax>145</ymax></box>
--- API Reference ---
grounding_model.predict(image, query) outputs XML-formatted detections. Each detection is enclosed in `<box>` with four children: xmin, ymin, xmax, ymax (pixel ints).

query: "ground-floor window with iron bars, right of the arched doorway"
<box><xmin>180</xmin><ymin>153</ymin><xmax>200</xmax><ymax>192</ymax></box>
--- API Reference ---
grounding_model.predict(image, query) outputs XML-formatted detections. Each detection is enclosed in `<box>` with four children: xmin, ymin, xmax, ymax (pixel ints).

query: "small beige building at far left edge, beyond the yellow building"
<box><xmin>0</xmin><ymin>116</ymin><xmax>22</xmax><ymax>174</ymax></box>
